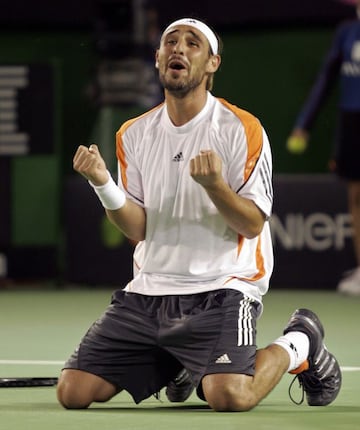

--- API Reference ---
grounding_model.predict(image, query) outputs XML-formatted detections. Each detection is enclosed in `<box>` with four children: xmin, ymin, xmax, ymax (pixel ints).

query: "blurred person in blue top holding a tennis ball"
<box><xmin>287</xmin><ymin>0</ymin><xmax>360</xmax><ymax>295</ymax></box>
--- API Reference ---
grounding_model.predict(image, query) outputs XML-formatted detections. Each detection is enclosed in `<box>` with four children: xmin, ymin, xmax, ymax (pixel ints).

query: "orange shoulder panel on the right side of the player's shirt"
<box><xmin>218</xmin><ymin>98</ymin><xmax>263</xmax><ymax>182</ymax></box>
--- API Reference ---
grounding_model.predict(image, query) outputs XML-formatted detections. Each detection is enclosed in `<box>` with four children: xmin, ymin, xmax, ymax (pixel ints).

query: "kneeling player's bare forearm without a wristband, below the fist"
<box><xmin>205</xmin><ymin>181</ymin><xmax>265</xmax><ymax>239</ymax></box>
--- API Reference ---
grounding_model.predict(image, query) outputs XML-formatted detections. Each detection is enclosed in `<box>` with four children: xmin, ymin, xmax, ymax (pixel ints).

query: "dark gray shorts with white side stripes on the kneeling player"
<box><xmin>64</xmin><ymin>289</ymin><xmax>260</xmax><ymax>403</ymax></box>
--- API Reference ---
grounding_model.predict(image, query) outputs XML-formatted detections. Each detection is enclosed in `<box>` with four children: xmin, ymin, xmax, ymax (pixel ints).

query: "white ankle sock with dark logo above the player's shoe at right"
<box><xmin>273</xmin><ymin>331</ymin><xmax>310</xmax><ymax>372</ymax></box>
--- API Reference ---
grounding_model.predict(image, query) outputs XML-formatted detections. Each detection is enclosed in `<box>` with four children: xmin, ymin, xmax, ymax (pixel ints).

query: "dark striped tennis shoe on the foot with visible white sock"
<box><xmin>284</xmin><ymin>309</ymin><xmax>342</xmax><ymax>406</ymax></box>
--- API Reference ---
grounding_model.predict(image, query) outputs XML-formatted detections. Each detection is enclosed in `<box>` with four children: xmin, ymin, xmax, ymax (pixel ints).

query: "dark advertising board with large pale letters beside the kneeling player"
<box><xmin>270</xmin><ymin>175</ymin><xmax>356</xmax><ymax>289</ymax></box>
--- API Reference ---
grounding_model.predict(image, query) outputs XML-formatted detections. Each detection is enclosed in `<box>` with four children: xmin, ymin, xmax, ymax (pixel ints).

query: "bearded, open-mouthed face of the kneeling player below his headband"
<box><xmin>156</xmin><ymin>25</ymin><xmax>211</xmax><ymax>97</ymax></box>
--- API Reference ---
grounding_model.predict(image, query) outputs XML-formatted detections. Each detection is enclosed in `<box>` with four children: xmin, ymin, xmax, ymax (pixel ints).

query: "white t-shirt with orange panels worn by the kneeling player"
<box><xmin>116</xmin><ymin>93</ymin><xmax>273</xmax><ymax>300</ymax></box>
